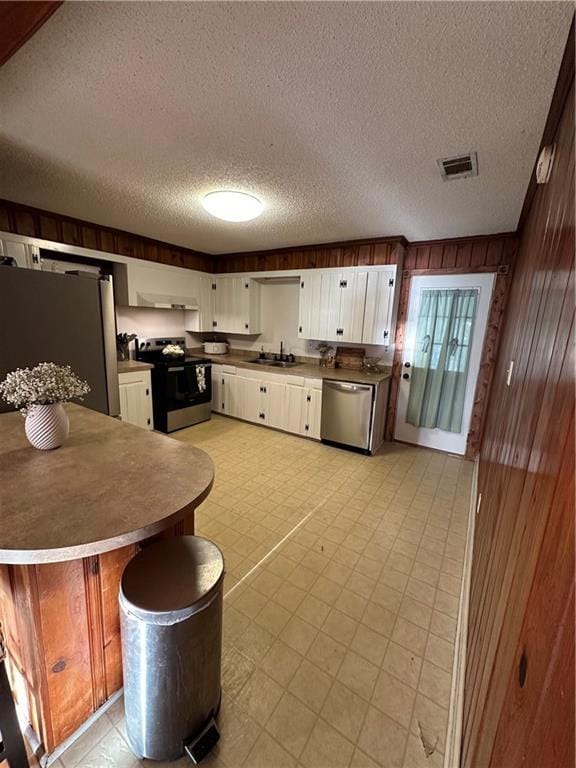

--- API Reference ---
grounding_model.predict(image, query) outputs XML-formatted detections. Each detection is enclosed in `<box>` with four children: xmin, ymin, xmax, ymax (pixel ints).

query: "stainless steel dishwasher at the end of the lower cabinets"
<box><xmin>320</xmin><ymin>379</ymin><xmax>375</xmax><ymax>453</ymax></box>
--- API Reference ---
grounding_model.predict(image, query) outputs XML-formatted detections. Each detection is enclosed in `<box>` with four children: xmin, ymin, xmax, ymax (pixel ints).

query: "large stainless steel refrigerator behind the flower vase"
<box><xmin>0</xmin><ymin>266</ymin><xmax>120</xmax><ymax>416</ymax></box>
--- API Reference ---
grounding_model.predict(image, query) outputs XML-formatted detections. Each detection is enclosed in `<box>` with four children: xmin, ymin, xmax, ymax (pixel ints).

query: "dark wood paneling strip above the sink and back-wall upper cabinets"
<box><xmin>214</xmin><ymin>237</ymin><xmax>407</xmax><ymax>274</ymax></box>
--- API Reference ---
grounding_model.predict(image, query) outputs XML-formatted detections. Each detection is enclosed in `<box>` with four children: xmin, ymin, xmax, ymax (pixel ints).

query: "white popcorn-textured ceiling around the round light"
<box><xmin>0</xmin><ymin>2</ymin><xmax>573</xmax><ymax>253</ymax></box>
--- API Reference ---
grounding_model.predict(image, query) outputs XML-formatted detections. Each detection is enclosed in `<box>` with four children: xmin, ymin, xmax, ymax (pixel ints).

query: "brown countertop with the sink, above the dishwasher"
<box><xmin>186</xmin><ymin>349</ymin><xmax>391</xmax><ymax>384</ymax></box>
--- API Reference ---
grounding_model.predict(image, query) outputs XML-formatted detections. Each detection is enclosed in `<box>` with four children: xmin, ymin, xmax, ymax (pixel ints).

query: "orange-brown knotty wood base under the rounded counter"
<box><xmin>0</xmin><ymin>515</ymin><xmax>194</xmax><ymax>755</ymax></box>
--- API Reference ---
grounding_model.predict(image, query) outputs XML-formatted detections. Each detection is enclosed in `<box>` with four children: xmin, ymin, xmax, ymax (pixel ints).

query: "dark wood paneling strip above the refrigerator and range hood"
<box><xmin>0</xmin><ymin>200</ymin><xmax>214</xmax><ymax>272</ymax></box>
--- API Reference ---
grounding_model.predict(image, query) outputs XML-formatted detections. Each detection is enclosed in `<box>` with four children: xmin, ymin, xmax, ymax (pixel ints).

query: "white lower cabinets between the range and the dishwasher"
<box><xmin>212</xmin><ymin>365</ymin><xmax>322</xmax><ymax>440</ymax></box>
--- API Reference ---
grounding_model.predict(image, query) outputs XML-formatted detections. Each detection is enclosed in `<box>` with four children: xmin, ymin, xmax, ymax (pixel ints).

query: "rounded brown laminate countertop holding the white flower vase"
<box><xmin>0</xmin><ymin>404</ymin><xmax>214</xmax><ymax>565</ymax></box>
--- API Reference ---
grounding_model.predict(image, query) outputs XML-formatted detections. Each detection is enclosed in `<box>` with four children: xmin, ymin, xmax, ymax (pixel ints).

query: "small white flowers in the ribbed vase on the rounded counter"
<box><xmin>0</xmin><ymin>363</ymin><xmax>90</xmax><ymax>414</ymax></box>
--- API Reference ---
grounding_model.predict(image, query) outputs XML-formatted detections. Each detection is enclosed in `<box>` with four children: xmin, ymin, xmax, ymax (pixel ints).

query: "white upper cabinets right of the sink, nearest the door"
<box><xmin>298</xmin><ymin>266</ymin><xmax>398</xmax><ymax>346</ymax></box>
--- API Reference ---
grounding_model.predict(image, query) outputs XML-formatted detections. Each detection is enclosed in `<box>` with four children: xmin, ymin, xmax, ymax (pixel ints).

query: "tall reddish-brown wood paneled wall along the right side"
<box><xmin>462</xmin><ymin>61</ymin><xmax>575</xmax><ymax>768</ymax></box>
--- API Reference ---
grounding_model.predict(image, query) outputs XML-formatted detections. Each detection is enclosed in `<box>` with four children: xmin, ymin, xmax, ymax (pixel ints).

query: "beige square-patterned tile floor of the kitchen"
<box><xmin>49</xmin><ymin>416</ymin><xmax>473</xmax><ymax>768</ymax></box>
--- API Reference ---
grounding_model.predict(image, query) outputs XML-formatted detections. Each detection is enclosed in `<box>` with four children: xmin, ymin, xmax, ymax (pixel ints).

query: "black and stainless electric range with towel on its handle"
<box><xmin>136</xmin><ymin>338</ymin><xmax>212</xmax><ymax>432</ymax></box>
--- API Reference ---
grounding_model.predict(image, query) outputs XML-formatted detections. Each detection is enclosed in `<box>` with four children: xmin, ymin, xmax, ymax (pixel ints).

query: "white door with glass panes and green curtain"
<box><xmin>394</xmin><ymin>273</ymin><xmax>495</xmax><ymax>454</ymax></box>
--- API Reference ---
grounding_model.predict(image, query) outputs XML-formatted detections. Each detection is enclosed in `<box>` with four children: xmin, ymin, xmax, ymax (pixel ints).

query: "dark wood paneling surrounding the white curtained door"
<box><xmin>387</xmin><ymin>233</ymin><xmax>517</xmax><ymax>457</ymax></box>
